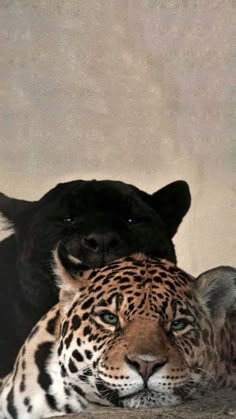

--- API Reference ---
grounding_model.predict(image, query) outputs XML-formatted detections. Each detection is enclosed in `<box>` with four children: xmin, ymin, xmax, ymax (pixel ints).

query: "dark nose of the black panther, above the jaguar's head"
<box><xmin>82</xmin><ymin>232</ymin><xmax>120</xmax><ymax>252</ymax></box>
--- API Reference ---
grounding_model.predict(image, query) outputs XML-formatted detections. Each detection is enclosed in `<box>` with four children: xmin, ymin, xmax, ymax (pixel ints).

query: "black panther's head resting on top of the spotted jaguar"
<box><xmin>0</xmin><ymin>180</ymin><xmax>190</xmax><ymax>308</ymax></box>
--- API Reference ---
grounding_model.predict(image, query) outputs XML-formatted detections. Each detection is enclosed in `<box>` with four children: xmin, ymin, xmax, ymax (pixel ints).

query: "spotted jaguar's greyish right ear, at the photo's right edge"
<box><xmin>195</xmin><ymin>266</ymin><xmax>236</xmax><ymax>328</ymax></box>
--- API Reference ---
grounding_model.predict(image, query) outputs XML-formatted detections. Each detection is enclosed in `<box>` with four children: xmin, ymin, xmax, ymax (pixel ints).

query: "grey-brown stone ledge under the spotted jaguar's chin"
<box><xmin>50</xmin><ymin>391</ymin><xmax>236</xmax><ymax>419</ymax></box>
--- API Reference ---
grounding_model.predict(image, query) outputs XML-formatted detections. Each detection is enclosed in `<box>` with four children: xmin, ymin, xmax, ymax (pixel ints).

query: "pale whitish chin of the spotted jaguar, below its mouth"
<box><xmin>119</xmin><ymin>389</ymin><xmax>181</xmax><ymax>409</ymax></box>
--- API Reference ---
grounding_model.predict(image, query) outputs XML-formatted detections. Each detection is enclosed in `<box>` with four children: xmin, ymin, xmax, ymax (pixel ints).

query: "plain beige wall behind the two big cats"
<box><xmin>0</xmin><ymin>0</ymin><xmax>236</xmax><ymax>274</ymax></box>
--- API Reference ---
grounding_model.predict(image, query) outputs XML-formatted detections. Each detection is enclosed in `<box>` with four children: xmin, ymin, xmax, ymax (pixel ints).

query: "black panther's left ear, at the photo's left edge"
<box><xmin>0</xmin><ymin>192</ymin><xmax>34</xmax><ymax>226</ymax></box>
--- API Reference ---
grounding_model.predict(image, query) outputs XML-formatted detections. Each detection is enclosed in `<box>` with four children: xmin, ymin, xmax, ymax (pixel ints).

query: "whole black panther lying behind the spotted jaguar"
<box><xmin>0</xmin><ymin>180</ymin><xmax>190</xmax><ymax>376</ymax></box>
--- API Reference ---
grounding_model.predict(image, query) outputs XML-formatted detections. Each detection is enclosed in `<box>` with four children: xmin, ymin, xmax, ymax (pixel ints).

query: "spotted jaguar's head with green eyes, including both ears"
<box><xmin>55</xmin><ymin>246</ymin><xmax>236</xmax><ymax>408</ymax></box>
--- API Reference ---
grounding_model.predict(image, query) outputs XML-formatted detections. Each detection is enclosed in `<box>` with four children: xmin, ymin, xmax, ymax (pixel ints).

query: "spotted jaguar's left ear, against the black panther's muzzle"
<box><xmin>53</xmin><ymin>242</ymin><xmax>91</xmax><ymax>313</ymax></box>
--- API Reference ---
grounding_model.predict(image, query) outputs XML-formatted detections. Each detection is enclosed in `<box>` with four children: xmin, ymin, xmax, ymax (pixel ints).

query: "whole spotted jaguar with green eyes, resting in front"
<box><xmin>0</xmin><ymin>251</ymin><xmax>236</xmax><ymax>419</ymax></box>
